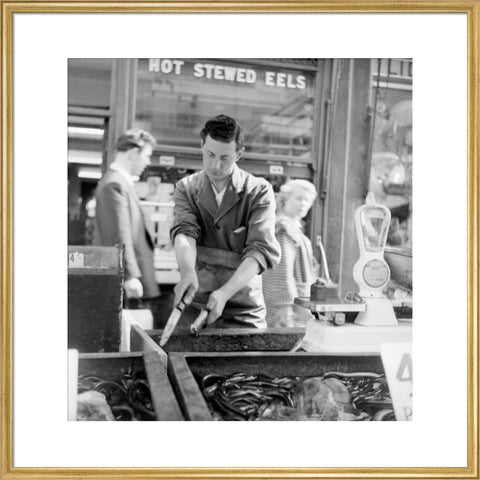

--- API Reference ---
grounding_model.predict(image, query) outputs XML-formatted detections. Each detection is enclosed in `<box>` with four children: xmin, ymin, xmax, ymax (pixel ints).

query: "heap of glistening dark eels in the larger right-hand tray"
<box><xmin>201</xmin><ymin>372</ymin><xmax>395</xmax><ymax>421</ymax></box>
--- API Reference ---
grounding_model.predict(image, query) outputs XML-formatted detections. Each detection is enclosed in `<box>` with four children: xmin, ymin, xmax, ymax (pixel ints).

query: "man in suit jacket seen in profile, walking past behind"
<box><xmin>93</xmin><ymin>129</ymin><xmax>160</xmax><ymax>300</ymax></box>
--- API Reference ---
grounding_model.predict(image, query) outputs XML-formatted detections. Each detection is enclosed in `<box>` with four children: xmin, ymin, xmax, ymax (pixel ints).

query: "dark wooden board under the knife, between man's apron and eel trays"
<box><xmin>145</xmin><ymin>328</ymin><xmax>305</xmax><ymax>353</ymax></box>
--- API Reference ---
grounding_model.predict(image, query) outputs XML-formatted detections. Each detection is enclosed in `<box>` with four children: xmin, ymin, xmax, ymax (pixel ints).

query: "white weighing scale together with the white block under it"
<box><xmin>295</xmin><ymin>194</ymin><xmax>412</xmax><ymax>353</ymax></box>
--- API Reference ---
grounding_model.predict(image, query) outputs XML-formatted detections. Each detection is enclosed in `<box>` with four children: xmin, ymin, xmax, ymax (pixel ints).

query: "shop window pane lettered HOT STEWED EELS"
<box><xmin>135</xmin><ymin>59</ymin><xmax>316</xmax><ymax>160</ymax></box>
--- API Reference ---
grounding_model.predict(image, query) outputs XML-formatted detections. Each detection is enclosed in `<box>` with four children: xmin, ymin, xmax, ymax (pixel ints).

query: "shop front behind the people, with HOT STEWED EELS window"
<box><xmin>69</xmin><ymin>58</ymin><xmax>411</xmax><ymax>292</ymax></box>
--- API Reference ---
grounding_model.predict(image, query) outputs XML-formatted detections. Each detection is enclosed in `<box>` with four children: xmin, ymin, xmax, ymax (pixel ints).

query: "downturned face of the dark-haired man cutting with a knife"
<box><xmin>202</xmin><ymin>135</ymin><xmax>241</xmax><ymax>182</ymax></box>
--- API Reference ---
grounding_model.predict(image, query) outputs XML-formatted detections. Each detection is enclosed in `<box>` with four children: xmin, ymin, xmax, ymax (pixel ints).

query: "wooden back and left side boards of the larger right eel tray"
<box><xmin>168</xmin><ymin>352</ymin><xmax>385</xmax><ymax>421</ymax></box>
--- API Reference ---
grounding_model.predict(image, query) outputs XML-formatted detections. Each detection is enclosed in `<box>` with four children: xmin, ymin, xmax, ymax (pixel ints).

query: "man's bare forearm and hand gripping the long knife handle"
<box><xmin>174</xmin><ymin>233</ymin><xmax>198</xmax><ymax>305</ymax></box>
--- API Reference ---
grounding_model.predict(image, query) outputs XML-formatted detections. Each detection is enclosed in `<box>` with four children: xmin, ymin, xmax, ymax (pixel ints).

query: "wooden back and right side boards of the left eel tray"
<box><xmin>78</xmin><ymin>352</ymin><xmax>183</xmax><ymax>421</ymax></box>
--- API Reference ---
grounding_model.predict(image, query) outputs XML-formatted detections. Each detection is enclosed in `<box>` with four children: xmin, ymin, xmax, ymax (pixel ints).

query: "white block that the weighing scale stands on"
<box><xmin>302</xmin><ymin>319</ymin><xmax>412</xmax><ymax>353</ymax></box>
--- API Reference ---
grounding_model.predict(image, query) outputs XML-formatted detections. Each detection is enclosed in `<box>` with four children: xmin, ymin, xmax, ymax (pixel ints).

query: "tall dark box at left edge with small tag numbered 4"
<box><xmin>68</xmin><ymin>245</ymin><xmax>124</xmax><ymax>353</ymax></box>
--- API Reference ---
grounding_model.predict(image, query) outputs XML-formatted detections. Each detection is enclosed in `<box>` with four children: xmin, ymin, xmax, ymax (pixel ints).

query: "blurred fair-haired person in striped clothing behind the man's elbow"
<box><xmin>263</xmin><ymin>180</ymin><xmax>318</xmax><ymax>327</ymax></box>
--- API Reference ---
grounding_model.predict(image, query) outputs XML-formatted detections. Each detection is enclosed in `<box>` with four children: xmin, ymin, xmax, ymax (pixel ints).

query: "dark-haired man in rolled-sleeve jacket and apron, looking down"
<box><xmin>171</xmin><ymin>115</ymin><xmax>280</xmax><ymax>328</ymax></box>
